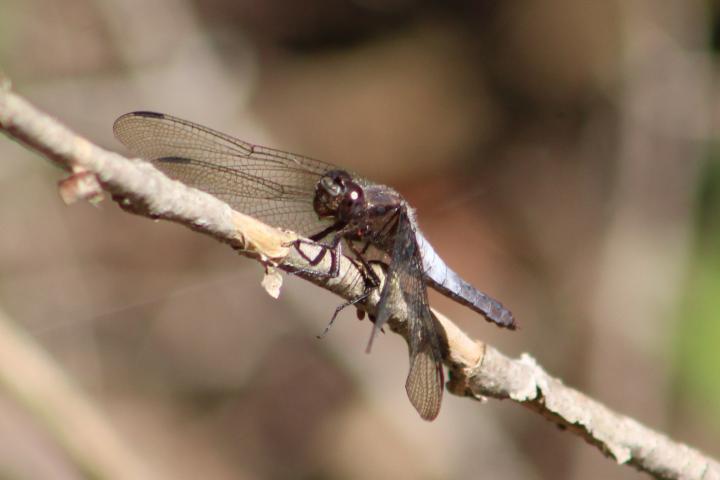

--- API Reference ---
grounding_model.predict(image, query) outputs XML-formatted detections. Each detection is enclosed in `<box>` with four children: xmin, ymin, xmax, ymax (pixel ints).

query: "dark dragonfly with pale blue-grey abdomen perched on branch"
<box><xmin>113</xmin><ymin>111</ymin><xmax>516</xmax><ymax>421</ymax></box>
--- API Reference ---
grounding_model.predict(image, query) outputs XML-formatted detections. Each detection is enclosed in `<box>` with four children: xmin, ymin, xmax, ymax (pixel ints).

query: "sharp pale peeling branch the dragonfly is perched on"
<box><xmin>0</xmin><ymin>88</ymin><xmax>720</xmax><ymax>480</ymax></box>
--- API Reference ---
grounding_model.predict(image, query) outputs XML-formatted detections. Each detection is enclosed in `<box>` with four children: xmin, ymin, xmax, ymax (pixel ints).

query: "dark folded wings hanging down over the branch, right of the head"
<box><xmin>373</xmin><ymin>208</ymin><xmax>444</xmax><ymax>420</ymax></box>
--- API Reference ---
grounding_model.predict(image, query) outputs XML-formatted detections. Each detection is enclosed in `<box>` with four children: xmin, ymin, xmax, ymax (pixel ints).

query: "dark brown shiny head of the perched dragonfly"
<box><xmin>313</xmin><ymin>170</ymin><xmax>365</xmax><ymax>222</ymax></box>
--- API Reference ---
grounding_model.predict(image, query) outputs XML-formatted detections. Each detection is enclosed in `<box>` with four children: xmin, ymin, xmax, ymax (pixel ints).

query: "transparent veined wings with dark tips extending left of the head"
<box><xmin>113</xmin><ymin>112</ymin><xmax>336</xmax><ymax>235</ymax></box>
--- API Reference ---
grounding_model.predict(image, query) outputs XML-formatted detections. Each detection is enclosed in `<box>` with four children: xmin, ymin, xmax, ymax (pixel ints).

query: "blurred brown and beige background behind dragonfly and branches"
<box><xmin>0</xmin><ymin>0</ymin><xmax>720</xmax><ymax>479</ymax></box>
